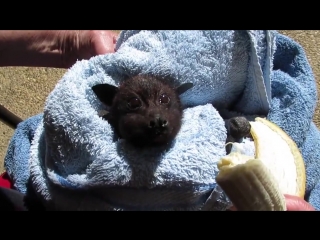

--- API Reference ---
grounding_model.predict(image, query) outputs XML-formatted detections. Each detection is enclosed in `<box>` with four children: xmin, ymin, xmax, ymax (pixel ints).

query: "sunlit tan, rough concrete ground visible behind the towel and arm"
<box><xmin>0</xmin><ymin>30</ymin><xmax>320</xmax><ymax>173</ymax></box>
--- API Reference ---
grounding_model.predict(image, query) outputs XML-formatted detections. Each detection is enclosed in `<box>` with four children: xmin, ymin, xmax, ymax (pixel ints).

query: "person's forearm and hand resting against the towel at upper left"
<box><xmin>0</xmin><ymin>30</ymin><xmax>118</xmax><ymax>68</ymax></box>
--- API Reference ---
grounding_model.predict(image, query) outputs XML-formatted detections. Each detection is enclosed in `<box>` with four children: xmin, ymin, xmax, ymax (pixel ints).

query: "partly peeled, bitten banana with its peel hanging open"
<box><xmin>216</xmin><ymin>117</ymin><xmax>306</xmax><ymax>211</ymax></box>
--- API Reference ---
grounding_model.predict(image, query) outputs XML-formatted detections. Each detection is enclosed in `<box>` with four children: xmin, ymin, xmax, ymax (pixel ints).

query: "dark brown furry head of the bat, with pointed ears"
<box><xmin>92</xmin><ymin>75</ymin><xmax>193</xmax><ymax>146</ymax></box>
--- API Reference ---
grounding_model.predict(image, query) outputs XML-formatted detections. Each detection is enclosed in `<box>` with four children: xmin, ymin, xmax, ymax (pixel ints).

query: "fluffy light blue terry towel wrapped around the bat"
<box><xmin>5</xmin><ymin>30</ymin><xmax>320</xmax><ymax>210</ymax></box>
